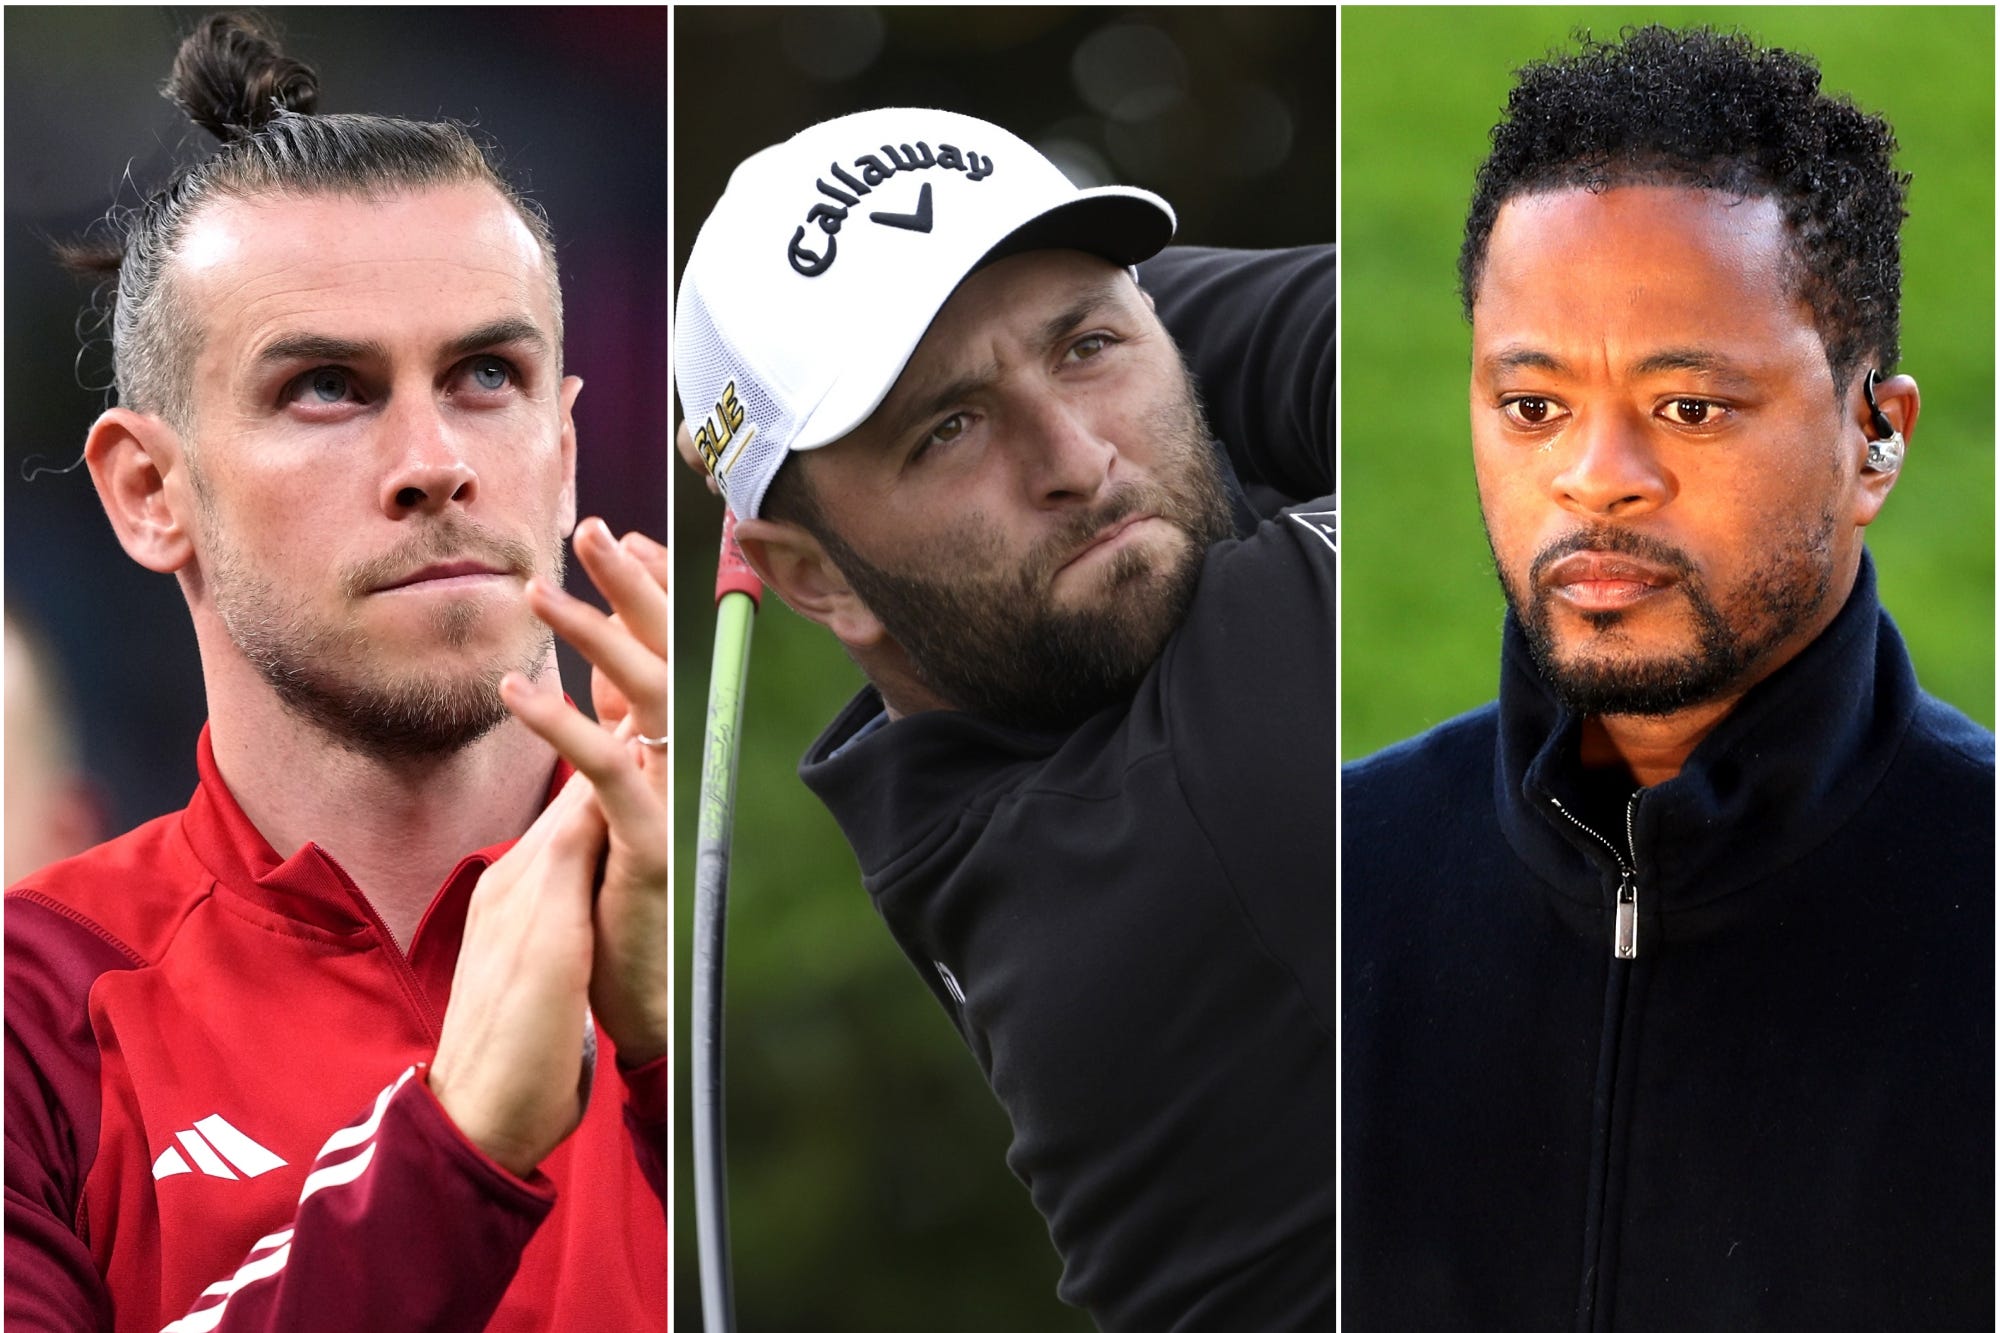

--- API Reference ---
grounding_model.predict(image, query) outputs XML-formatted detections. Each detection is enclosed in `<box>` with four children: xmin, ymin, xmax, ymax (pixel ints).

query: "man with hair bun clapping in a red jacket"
<box><xmin>6</xmin><ymin>14</ymin><xmax>670</xmax><ymax>1333</ymax></box>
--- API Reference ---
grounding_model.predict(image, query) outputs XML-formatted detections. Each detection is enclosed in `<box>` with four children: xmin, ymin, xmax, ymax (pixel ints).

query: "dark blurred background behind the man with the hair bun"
<box><xmin>4</xmin><ymin>6</ymin><xmax>670</xmax><ymax>833</ymax></box>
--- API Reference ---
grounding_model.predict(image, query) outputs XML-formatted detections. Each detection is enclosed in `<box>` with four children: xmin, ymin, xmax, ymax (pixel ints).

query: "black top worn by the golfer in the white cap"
<box><xmin>800</xmin><ymin>250</ymin><xmax>1338</xmax><ymax>1333</ymax></box>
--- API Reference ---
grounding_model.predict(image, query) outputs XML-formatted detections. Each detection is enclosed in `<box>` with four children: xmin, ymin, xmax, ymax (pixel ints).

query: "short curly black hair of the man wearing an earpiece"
<box><xmin>1458</xmin><ymin>26</ymin><xmax>1910</xmax><ymax>394</ymax></box>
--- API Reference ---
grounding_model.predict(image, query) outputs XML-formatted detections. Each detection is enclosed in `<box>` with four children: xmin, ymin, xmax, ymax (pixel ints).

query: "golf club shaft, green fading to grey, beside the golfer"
<box><xmin>688</xmin><ymin>518</ymin><xmax>760</xmax><ymax>1333</ymax></box>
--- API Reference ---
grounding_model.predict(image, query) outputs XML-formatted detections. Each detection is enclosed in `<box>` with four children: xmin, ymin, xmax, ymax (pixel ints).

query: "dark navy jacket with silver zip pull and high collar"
<box><xmin>1342</xmin><ymin>556</ymin><xmax>1994</xmax><ymax>1333</ymax></box>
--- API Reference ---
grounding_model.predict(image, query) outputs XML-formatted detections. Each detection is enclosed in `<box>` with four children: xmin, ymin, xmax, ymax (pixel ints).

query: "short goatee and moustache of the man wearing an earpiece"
<box><xmin>1488</xmin><ymin>510</ymin><xmax>1834</xmax><ymax>717</ymax></box>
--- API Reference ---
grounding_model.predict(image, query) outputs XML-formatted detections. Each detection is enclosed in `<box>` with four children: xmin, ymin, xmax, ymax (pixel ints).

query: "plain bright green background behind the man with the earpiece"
<box><xmin>1340</xmin><ymin>6</ymin><xmax>1994</xmax><ymax>759</ymax></box>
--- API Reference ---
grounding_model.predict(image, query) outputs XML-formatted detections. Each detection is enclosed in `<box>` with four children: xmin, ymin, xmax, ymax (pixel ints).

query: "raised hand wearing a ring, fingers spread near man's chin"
<box><xmin>508</xmin><ymin>518</ymin><xmax>674</xmax><ymax>1065</ymax></box>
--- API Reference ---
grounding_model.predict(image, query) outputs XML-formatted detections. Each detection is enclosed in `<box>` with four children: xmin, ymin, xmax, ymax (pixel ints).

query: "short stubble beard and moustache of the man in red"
<box><xmin>194</xmin><ymin>480</ymin><xmax>562</xmax><ymax>763</ymax></box>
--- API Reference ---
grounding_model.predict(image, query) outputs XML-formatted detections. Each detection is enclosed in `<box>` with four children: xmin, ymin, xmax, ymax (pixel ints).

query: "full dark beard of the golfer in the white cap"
<box><xmin>820</xmin><ymin>376</ymin><xmax>1234</xmax><ymax>731</ymax></box>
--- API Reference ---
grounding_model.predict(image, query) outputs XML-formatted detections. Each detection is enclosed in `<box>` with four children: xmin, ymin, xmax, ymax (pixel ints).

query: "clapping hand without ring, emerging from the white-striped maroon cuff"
<box><xmin>430</xmin><ymin>777</ymin><xmax>604</xmax><ymax>1177</ymax></box>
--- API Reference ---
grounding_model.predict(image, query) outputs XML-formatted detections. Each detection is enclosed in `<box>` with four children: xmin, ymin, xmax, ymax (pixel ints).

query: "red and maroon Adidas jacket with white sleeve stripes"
<box><xmin>6</xmin><ymin>731</ymin><xmax>668</xmax><ymax>1333</ymax></box>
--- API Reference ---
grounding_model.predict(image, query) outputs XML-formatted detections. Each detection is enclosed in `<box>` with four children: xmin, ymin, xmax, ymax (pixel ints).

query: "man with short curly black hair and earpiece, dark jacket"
<box><xmin>1342</xmin><ymin>28</ymin><xmax>1994</xmax><ymax>1331</ymax></box>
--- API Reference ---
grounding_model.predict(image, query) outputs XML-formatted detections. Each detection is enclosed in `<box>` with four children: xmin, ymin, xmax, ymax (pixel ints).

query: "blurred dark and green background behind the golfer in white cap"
<box><xmin>672</xmin><ymin>6</ymin><xmax>1334</xmax><ymax>1333</ymax></box>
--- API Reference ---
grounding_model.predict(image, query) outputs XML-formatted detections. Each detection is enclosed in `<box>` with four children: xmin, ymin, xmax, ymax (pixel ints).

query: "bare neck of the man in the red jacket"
<box><xmin>208</xmin><ymin>644</ymin><xmax>562</xmax><ymax>949</ymax></box>
